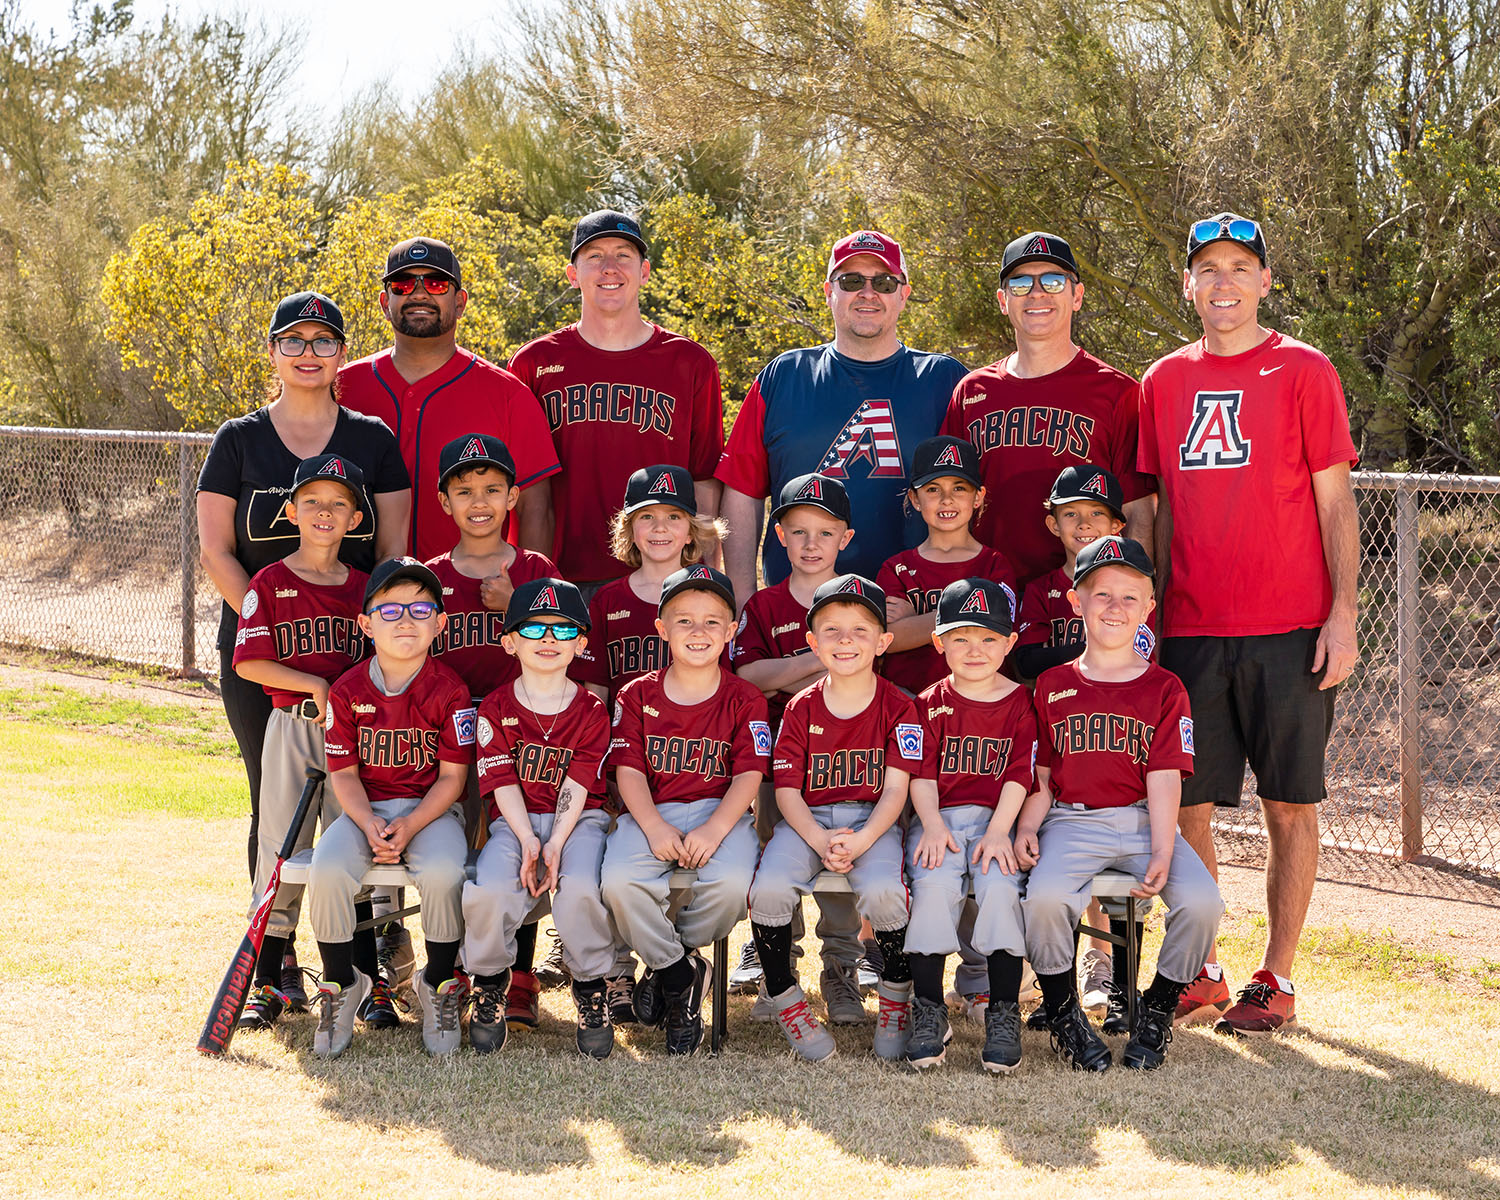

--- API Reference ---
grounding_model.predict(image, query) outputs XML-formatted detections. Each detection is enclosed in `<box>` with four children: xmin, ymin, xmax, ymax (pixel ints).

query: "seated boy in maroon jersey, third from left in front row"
<box><xmin>600</xmin><ymin>564</ymin><xmax>771</xmax><ymax>1055</ymax></box>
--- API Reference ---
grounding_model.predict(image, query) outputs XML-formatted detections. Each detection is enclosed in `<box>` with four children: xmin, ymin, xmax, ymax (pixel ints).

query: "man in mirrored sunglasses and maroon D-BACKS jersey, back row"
<box><xmin>942</xmin><ymin>233</ymin><xmax>1152</xmax><ymax>588</ymax></box>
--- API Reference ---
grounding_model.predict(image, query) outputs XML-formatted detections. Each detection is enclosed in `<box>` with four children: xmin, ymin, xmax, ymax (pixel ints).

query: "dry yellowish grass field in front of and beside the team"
<box><xmin>0</xmin><ymin>669</ymin><xmax>1500</xmax><ymax>1200</ymax></box>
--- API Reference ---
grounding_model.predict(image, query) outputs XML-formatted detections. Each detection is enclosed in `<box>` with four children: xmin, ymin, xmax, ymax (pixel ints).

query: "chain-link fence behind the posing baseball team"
<box><xmin>0</xmin><ymin>426</ymin><xmax>1500</xmax><ymax>875</ymax></box>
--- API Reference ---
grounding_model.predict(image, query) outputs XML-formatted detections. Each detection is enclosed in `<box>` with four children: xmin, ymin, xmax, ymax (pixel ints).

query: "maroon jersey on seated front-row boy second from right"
<box><xmin>915</xmin><ymin>677</ymin><xmax>1037</xmax><ymax>809</ymax></box>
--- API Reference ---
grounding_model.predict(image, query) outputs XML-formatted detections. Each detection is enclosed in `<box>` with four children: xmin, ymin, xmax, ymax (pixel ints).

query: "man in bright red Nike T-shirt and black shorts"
<box><xmin>1140</xmin><ymin>213</ymin><xmax>1359</xmax><ymax>1034</ymax></box>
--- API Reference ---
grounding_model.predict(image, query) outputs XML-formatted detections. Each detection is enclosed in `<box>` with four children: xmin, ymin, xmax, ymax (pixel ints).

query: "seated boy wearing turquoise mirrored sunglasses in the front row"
<box><xmin>464</xmin><ymin>579</ymin><xmax>615</xmax><ymax>1059</ymax></box>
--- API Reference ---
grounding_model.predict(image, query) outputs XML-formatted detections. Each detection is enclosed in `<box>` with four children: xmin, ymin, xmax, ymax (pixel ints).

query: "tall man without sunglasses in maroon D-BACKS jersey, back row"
<box><xmin>510</xmin><ymin>209</ymin><xmax>725</xmax><ymax>596</ymax></box>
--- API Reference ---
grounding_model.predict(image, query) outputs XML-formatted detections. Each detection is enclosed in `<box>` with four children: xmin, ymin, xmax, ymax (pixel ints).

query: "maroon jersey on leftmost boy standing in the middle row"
<box><xmin>234</xmin><ymin>563</ymin><xmax>369</xmax><ymax>708</ymax></box>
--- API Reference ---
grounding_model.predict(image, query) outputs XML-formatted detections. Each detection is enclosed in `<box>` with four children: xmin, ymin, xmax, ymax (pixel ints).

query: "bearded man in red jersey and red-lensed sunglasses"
<box><xmin>339</xmin><ymin>237</ymin><xmax>558</xmax><ymax>563</ymax></box>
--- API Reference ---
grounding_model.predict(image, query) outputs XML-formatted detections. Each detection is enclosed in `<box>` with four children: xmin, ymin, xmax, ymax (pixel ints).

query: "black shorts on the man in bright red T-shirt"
<box><xmin>1161</xmin><ymin>629</ymin><xmax>1338</xmax><ymax>809</ymax></box>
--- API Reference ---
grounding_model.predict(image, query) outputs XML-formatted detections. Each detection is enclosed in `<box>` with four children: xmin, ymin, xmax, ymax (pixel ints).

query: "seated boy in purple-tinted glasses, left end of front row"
<box><xmin>308</xmin><ymin>558</ymin><xmax>474</xmax><ymax>1058</ymax></box>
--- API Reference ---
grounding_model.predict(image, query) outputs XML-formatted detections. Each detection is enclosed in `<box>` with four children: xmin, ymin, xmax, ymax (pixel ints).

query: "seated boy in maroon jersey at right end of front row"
<box><xmin>1016</xmin><ymin>537</ymin><xmax>1224</xmax><ymax>1071</ymax></box>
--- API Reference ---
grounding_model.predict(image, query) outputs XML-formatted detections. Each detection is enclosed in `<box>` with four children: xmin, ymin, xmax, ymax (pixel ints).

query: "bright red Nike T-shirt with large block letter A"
<box><xmin>1140</xmin><ymin>333</ymin><xmax>1359</xmax><ymax>638</ymax></box>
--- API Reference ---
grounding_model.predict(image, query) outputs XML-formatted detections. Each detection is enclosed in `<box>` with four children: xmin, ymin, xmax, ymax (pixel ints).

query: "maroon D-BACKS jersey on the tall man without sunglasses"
<box><xmin>510</xmin><ymin>326</ymin><xmax>725</xmax><ymax>582</ymax></box>
